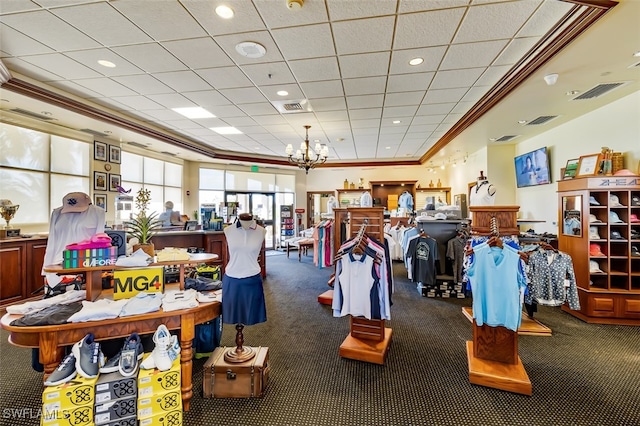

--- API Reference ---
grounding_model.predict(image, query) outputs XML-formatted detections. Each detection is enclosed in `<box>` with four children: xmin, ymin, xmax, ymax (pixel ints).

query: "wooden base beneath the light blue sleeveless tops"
<box><xmin>467</xmin><ymin>320</ymin><xmax>532</xmax><ymax>396</ymax></box>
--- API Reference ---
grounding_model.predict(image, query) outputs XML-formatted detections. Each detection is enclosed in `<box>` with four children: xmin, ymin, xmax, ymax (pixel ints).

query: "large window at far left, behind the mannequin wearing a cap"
<box><xmin>0</xmin><ymin>123</ymin><xmax>93</xmax><ymax>225</ymax></box>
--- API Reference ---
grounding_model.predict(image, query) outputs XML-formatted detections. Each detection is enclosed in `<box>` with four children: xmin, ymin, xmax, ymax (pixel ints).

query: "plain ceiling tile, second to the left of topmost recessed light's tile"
<box><xmin>50</xmin><ymin>2</ymin><xmax>153</xmax><ymax>46</ymax></box>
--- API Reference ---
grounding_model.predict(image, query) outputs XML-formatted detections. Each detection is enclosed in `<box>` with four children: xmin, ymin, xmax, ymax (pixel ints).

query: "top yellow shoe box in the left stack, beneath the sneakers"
<box><xmin>42</xmin><ymin>375</ymin><xmax>98</xmax><ymax>412</ymax></box>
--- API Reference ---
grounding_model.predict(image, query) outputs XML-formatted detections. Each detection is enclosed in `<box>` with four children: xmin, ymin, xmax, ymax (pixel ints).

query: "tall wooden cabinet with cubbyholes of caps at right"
<box><xmin>558</xmin><ymin>176</ymin><xmax>640</xmax><ymax>325</ymax></box>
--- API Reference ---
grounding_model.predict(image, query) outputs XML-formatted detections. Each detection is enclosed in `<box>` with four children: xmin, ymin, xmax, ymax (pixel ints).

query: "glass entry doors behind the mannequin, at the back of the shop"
<box><xmin>225</xmin><ymin>192</ymin><xmax>276</xmax><ymax>250</ymax></box>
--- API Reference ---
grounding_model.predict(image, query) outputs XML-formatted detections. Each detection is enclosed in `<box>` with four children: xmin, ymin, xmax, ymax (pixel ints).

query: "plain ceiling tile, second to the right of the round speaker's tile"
<box><xmin>332</xmin><ymin>16</ymin><xmax>394</xmax><ymax>55</ymax></box>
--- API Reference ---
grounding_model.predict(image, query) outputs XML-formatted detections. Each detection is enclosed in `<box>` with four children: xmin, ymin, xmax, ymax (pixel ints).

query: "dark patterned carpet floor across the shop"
<box><xmin>0</xmin><ymin>256</ymin><xmax>640</xmax><ymax>426</ymax></box>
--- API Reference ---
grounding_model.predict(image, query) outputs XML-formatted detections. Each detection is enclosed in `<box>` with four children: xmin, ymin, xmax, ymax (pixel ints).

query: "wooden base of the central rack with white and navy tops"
<box><xmin>339</xmin><ymin>317</ymin><xmax>392</xmax><ymax>364</ymax></box>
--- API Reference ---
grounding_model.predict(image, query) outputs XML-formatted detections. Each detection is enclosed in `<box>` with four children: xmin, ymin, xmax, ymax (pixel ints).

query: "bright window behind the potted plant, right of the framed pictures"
<box><xmin>120</xmin><ymin>151</ymin><xmax>188</xmax><ymax>215</ymax></box>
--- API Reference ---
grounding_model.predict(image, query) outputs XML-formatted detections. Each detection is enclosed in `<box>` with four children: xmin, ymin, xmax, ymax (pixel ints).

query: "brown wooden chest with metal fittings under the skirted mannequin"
<box><xmin>202</xmin><ymin>347</ymin><xmax>270</xmax><ymax>398</ymax></box>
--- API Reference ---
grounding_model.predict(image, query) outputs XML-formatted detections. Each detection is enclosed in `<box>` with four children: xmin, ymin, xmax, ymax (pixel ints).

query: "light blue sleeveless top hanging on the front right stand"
<box><xmin>467</xmin><ymin>242</ymin><xmax>527</xmax><ymax>331</ymax></box>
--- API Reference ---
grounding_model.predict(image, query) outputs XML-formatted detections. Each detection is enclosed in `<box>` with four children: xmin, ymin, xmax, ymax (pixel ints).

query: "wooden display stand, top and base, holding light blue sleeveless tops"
<box><xmin>465</xmin><ymin>206</ymin><xmax>532</xmax><ymax>396</ymax></box>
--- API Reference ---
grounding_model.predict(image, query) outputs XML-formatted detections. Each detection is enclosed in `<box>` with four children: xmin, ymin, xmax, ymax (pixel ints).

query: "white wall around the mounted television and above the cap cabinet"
<box><xmin>516</xmin><ymin>91</ymin><xmax>640</xmax><ymax>233</ymax></box>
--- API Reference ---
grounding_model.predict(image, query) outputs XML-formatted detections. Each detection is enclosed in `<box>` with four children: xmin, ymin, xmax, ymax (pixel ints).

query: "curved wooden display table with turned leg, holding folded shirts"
<box><xmin>0</xmin><ymin>294</ymin><xmax>221</xmax><ymax>411</ymax></box>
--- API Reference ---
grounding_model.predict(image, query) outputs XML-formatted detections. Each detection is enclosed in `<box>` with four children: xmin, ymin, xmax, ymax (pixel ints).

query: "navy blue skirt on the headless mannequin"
<box><xmin>222</xmin><ymin>274</ymin><xmax>267</xmax><ymax>325</ymax></box>
